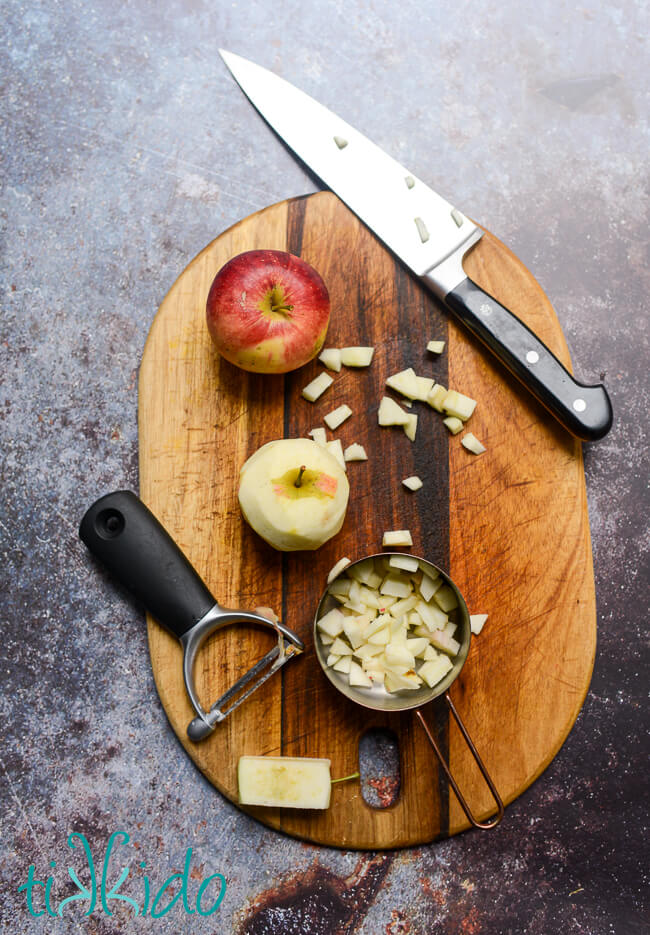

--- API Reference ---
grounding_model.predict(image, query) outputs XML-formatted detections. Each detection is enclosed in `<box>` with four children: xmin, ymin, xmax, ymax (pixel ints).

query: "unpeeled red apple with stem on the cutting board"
<box><xmin>206</xmin><ymin>250</ymin><xmax>330</xmax><ymax>373</ymax></box>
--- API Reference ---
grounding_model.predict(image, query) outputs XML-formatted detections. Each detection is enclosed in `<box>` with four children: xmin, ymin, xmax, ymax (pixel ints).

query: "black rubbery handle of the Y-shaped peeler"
<box><xmin>79</xmin><ymin>490</ymin><xmax>216</xmax><ymax>639</ymax></box>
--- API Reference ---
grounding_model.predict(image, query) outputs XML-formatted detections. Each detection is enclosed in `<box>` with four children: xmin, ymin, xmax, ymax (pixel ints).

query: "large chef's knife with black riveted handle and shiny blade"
<box><xmin>220</xmin><ymin>50</ymin><xmax>612</xmax><ymax>441</ymax></box>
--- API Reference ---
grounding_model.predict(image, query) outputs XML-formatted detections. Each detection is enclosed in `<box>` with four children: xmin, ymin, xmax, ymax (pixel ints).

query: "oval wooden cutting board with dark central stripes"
<box><xmin>139</xmin><ymin>192</ymin><xmax>596</xmax><ymax>849</ymax></box>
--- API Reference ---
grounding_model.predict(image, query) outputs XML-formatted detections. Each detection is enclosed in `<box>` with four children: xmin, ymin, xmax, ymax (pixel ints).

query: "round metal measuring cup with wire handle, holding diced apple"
<box><xmin>314</xmin><ymin>552</ymin><xmax>504</xmax><ymax>830</ymax></box>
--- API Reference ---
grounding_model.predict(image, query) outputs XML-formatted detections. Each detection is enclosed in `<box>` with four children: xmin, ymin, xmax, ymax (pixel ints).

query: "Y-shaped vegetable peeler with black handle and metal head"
<box><xmin>79</xmin><ymin>490</ymin><xmax>304</xmax><ymax>742</ymax></box>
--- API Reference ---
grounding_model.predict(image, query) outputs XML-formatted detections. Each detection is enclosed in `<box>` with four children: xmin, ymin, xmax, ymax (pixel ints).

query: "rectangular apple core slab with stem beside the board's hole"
<box><xmin>237</xmin><ymin>756</ymin><xmax>332</xmax><ymax>809</ymax></box>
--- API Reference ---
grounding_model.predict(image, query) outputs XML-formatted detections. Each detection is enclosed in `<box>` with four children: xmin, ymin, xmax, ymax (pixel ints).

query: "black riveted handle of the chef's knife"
<box><xmin>443</xmin><ymin>278</ymin><xmax>613</xmax><ymax>441</ymax></box>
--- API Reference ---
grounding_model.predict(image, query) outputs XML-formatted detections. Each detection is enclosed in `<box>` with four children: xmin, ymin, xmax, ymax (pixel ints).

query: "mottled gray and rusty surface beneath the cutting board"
<box><xmin>0</xmin><ymin>0</ymin><xmax>650</xmax><ymax>935</ymax></box>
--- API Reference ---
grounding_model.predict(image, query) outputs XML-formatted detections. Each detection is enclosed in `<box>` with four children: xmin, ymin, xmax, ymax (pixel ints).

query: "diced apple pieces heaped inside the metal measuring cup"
<box><xmin>317</xmin><ymin>553</ymin><xmax>461</xmax><ymax>693</ymax></box>
